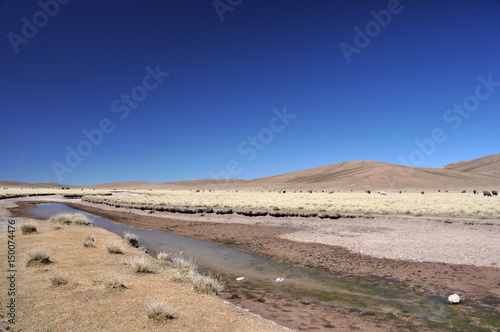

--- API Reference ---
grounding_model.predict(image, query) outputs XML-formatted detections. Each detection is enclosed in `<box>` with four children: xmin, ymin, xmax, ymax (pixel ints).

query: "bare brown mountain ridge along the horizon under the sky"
<box><xmin>0</xmin><ymin>154</ymin><xmax>500</xmax><ymax>190</ymax></box>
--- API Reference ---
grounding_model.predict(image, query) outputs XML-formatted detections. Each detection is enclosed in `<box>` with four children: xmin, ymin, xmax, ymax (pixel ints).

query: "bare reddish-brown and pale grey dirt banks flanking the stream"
<box><xmin>0</xmin><ymin>197</ymin><xmax>500</xmax><ymax>330</ymax></box>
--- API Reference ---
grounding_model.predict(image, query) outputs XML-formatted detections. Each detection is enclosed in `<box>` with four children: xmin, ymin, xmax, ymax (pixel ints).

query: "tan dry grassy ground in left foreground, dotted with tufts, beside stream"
<box><xmin>0</xmin><ymin>223</ymin><xmax>283</xmax><ymax>332</ymax></box>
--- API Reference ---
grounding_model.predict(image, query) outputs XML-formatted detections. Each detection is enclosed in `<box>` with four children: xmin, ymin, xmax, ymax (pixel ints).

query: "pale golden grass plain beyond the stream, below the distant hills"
<box><xmin>85</xmin><ymin>190</ymin><xmax>500</xmax><ymax>219</ymax></box>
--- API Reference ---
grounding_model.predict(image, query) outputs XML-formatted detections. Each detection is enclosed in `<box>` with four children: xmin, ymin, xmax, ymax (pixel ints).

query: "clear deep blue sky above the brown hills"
<box><xmin>0</xmin><ymin>0</ymin><xmax>500</xmax><ymax>185</ymax></box>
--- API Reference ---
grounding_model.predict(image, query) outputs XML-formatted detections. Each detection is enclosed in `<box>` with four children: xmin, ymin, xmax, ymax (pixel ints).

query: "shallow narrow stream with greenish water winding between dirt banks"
<box><xmin>28</xmin><ymin>204</ymin><xmax>500</xmax><ymax>326</ymax></box>
